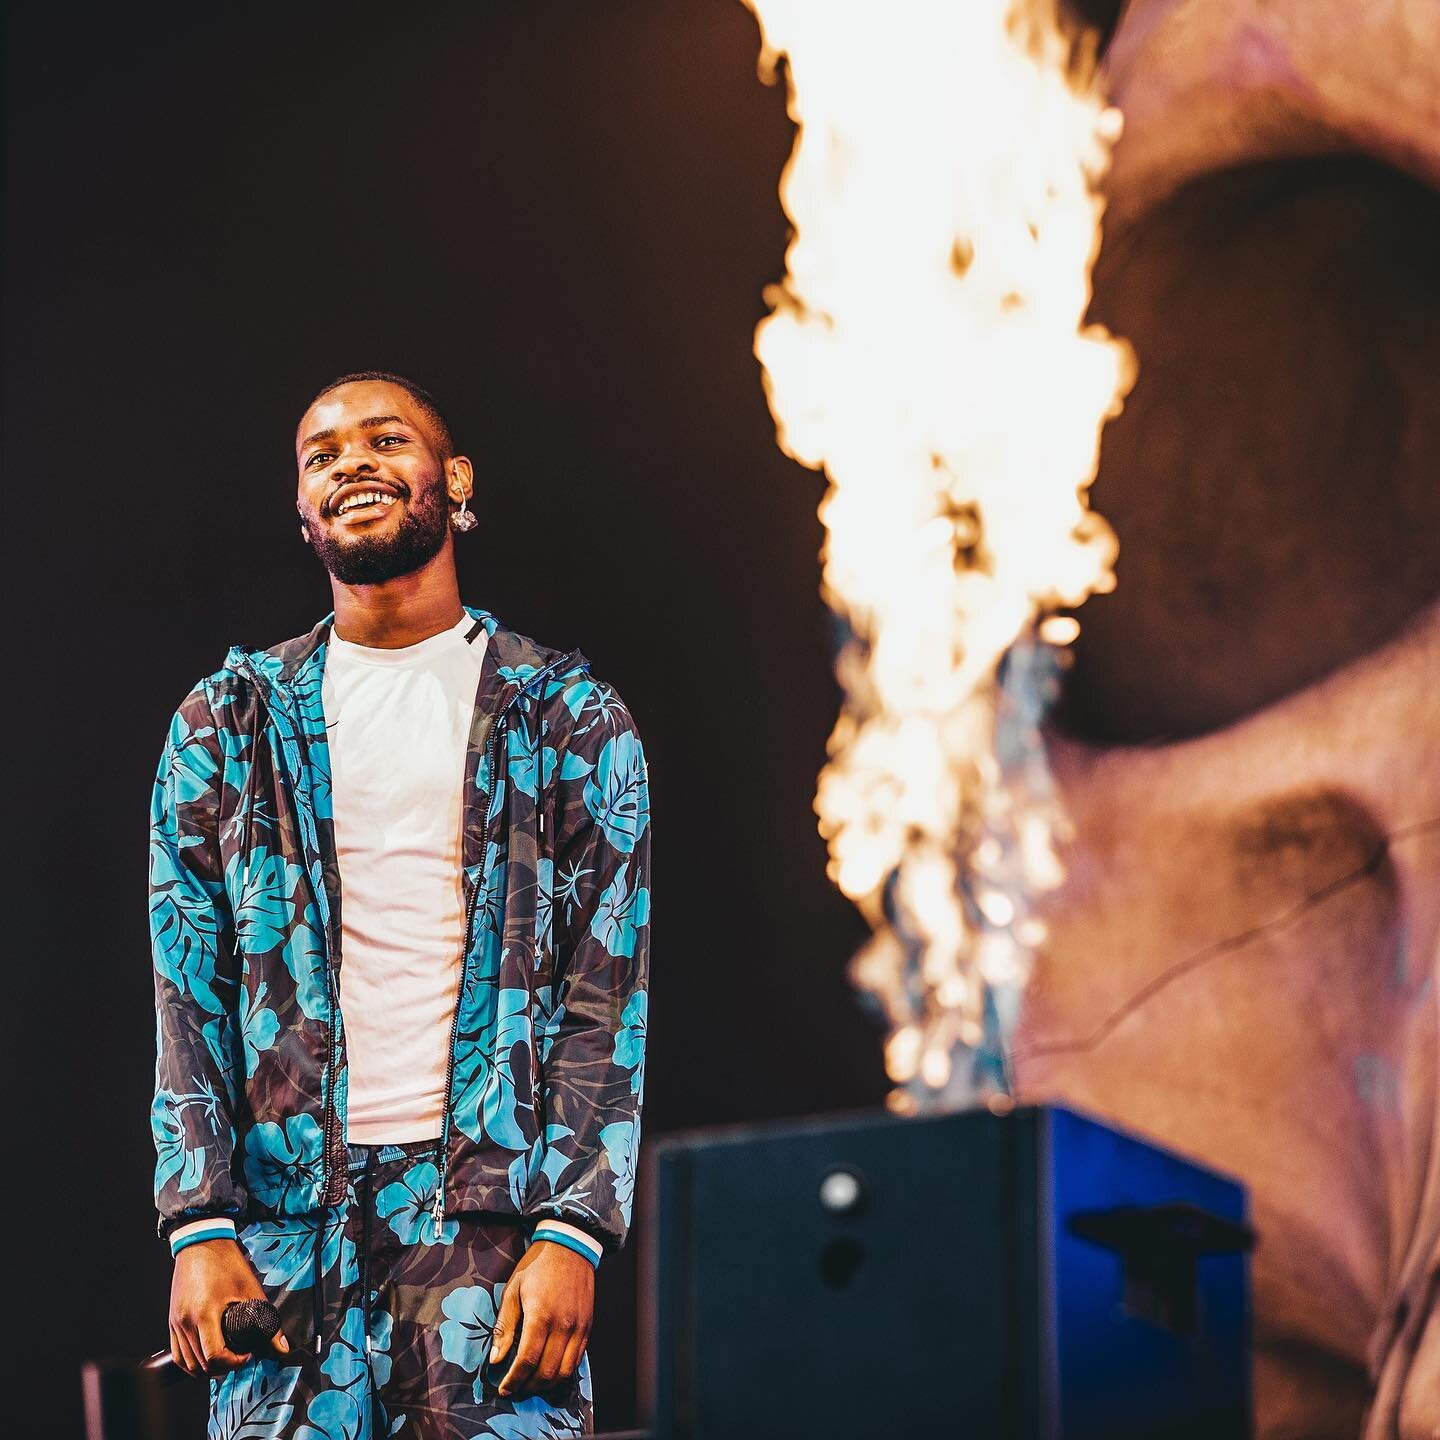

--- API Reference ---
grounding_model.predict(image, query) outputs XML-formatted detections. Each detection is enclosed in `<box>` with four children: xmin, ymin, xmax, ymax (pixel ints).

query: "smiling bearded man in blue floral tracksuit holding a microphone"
<box><xmin>150</xmin><ymin>372</ymin><xmax>649</xmax><ymax>1440</ymax></box>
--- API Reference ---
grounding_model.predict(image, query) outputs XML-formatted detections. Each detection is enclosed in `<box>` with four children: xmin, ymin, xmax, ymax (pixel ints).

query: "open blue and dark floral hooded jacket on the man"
<box><xmin>150</xmin><ymin>606</ymin><xmax>649</xmax><ymax>1250</ymax></box>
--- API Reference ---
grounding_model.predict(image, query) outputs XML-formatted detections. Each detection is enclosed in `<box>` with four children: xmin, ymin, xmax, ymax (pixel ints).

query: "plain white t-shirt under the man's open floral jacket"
<box><xmin>321</xmin><ymin>615</ymin><xmax>487</xmax><ymax>1145</ymax></box>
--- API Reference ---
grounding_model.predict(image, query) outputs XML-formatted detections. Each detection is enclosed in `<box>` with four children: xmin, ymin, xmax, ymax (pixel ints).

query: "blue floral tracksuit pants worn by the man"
<box><xmin>209</xmin><ymin>1140</ymin><xmax>593</xmax><ymax>1440</ymax></box>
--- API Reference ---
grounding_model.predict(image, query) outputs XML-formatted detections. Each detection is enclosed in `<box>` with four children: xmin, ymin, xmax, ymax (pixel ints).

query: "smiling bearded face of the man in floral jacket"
<box><xmin>295</xmin><ymin>380</ymin><xmax>449</xmax><ymax>585</ymax></box>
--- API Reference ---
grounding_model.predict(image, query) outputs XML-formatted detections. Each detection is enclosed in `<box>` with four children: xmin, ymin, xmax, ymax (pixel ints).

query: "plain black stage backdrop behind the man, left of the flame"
<box><xmin>3</xmin><ymin>0</ymin><xmax>884</xmax><ymax>1440</ymax></box>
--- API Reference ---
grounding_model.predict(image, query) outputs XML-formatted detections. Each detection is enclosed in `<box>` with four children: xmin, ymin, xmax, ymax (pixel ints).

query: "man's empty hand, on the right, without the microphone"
<box><xmin>490</xmin><ymin>1240</ymin><xmax>595</xmax><ymax>1398</ymax></box>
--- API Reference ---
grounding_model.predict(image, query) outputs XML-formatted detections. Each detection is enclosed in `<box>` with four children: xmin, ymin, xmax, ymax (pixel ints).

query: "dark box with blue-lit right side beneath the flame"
<box><xmin>641</xmin><ymin>1106</ymin><xmax>1251</xmax><ymax>1440</ymax></box>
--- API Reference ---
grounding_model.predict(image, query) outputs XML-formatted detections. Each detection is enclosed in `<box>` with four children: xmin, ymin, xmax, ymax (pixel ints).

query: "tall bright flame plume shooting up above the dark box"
<box><xmin>746</xmin><ymin>0</ymin><xmax>1135</xmax><ymax>1110</ymax></box>
